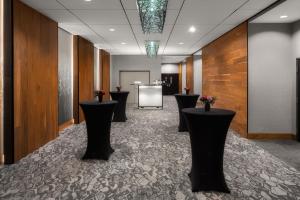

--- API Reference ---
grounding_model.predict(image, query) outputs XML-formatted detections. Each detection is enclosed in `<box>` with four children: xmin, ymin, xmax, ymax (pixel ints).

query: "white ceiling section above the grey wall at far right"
<box><xmin>251</xmin><ymin>0</ymin><xmax>300</xmax><ymax>23</ymax></box>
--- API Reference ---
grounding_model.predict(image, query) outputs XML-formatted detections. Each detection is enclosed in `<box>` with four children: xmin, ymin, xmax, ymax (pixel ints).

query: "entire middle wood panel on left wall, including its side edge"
<box><xmin>73</xmin><ymin>36</ymin><xmax>94</xmax><ymax>124</ymax></box>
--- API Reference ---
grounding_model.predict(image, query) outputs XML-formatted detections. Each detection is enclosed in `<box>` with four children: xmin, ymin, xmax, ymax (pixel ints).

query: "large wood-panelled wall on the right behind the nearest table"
<box><xmin>202</xmin><ymin>22</ymin><xmax>248</xmax><ymax>137</ymax></box>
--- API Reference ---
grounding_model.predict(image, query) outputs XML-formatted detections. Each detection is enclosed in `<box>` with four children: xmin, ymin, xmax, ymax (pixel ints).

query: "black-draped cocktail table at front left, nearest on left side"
<box><xmin>80</xmin><ymin>101</ymin><xmax>118</xmax><ymax>160</ymax></box>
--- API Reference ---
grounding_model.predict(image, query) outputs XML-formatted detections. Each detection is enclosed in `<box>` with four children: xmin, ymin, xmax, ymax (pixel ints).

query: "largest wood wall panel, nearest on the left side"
<box><xmin>13</xmin><ymin>0</ymin><xmax>58</xmax><ymax>161</ymax></box>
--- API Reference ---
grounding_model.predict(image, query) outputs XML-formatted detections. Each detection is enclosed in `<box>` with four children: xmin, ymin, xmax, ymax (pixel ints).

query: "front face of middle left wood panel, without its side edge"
<box><xmin>77</xmin><ymin>36</ymin><xmax>94</xmax><ymax>122</ymax></box>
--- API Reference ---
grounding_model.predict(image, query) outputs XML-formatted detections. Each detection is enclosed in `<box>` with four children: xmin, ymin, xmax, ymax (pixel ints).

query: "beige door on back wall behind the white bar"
<box><xmin>119</xmin><ymin>71</ymin><xmax>150</xmax><ymax>103</ymax></box>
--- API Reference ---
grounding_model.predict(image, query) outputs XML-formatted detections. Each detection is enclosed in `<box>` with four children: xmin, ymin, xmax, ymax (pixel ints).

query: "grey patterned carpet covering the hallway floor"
<box><xmin>0</xmin><ymin>97</ymin><xmax>300</xmax><ymax>200</ymax></box>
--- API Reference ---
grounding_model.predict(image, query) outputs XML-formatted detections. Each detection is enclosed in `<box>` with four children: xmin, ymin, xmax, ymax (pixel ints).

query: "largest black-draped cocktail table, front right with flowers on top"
<box><xmin>182</xmin><ymin>108</ymin><xmax>235</xmax><ymax>193</ymax></box>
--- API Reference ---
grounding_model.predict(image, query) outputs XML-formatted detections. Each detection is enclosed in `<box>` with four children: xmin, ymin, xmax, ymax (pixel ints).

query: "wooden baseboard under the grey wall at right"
<box><xmin>247</xmin><ymin>133</ymin><xmax>296</xmax><ymax>140</ymax></box>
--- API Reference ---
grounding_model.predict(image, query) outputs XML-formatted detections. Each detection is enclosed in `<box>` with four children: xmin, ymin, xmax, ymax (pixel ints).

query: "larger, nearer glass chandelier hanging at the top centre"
<box><xmin>137</xmin><ymin>0</ymin><xmax>168</xmax><ymax>34</ymax></box>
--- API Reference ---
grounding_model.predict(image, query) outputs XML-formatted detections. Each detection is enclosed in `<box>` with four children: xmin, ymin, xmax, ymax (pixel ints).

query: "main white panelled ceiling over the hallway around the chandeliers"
<box><xmin>22</xmin><ymin>0</ymin><xmax>278</xmax><ymax>55</ymax></box>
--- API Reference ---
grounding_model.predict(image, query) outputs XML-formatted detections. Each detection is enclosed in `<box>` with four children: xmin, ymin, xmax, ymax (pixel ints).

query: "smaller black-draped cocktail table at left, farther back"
<box><xmin>110</xmin><ymin>91</ymin><xmax>129</xmax><ymax>122</ymax></box>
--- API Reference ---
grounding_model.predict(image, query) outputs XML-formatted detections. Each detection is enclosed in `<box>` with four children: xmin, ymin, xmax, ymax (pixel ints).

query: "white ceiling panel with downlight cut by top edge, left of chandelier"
<box><xmin>58</xmin><ymin>0</ymin><xmax>122</xmax><ymax>10</ymax></box>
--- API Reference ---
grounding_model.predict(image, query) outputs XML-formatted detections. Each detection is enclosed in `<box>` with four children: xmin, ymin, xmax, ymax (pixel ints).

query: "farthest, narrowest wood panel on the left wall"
<box><xmin>100</xmin><ymin>49</ymin><xmax>110</xmax><ymax>100</ymax></box>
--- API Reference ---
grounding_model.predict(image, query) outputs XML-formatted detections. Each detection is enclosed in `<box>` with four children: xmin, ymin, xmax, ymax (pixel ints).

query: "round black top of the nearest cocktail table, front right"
<box><xmin>182</xmin><ymin>108</ymin><xmax>235</xmax><ymax>116</ymax></box>
